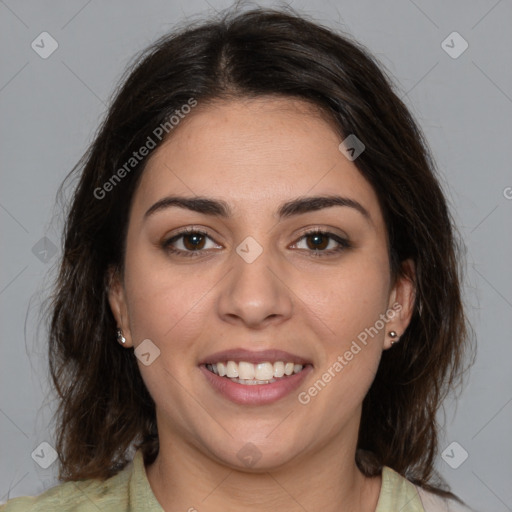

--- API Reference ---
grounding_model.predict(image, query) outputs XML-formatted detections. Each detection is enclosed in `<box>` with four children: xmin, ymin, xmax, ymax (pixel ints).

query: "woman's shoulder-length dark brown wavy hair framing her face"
<box><xmin>49</xmin><ymin>4</ymin><xmax>468</xmax><ymax>500</ymax></box>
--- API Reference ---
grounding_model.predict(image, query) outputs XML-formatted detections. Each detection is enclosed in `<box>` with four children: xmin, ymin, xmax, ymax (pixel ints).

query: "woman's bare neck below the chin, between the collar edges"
<box><xmin>146</xmin><ymin>420</ymin><xmax>381</xmax><ymax>512</ymax></box>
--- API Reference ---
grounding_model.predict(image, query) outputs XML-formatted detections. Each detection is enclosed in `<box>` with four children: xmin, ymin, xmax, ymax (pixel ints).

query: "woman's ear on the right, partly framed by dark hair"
<box><xmin>384</xmin><ymin>259</ymin><xmax>416</xmax><ymax>349</ymax></box>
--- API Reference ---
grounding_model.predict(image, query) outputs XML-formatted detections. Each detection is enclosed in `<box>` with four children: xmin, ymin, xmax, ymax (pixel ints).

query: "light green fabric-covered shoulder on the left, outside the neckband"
<box><xmin>0</xmin><ymin>462</ymin><xmax>133</xmax><ymax>512</ymax></box>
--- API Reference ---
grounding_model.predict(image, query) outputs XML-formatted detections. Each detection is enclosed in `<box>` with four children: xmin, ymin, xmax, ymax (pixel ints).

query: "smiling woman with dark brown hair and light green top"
<box><xmin>1</xmin><ymin>9</ymin><xmax>474</xmax><ymax>512</ymax></box>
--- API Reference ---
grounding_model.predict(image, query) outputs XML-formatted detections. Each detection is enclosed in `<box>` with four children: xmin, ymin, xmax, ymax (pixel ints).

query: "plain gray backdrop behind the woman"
<box><xmin>0</xmin><ymin>0</ymin><xmax>512</xmax><ymax>512</ymax></box>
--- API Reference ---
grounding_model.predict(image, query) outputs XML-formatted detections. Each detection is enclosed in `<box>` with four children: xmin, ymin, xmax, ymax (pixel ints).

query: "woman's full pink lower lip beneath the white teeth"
<box><xmin>199</xmin><ymin>364</ymin><xmax>313</xmax><ymax>405</ymax></box>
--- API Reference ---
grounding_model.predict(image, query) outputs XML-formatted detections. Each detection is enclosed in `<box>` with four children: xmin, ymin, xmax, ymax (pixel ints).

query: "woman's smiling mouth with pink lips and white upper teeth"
<box><xmin>199</xmin><ymin>349</ymin><xmax>313</xmax><ymax>405</ymax></box>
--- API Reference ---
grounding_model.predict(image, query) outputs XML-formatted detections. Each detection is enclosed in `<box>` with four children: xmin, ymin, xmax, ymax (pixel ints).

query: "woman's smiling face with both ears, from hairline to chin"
<box><xmin>110</xmin><ymin>98</ymin><xmax>412</xmax><ymax>470</ymax></box>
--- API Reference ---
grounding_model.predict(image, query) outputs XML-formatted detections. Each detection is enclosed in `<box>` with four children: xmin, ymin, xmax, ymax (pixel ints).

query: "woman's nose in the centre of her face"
<box><xmin>217</xmin><ymin>242</ymin><xmax>293</xmax><ymax>329</ymax></box>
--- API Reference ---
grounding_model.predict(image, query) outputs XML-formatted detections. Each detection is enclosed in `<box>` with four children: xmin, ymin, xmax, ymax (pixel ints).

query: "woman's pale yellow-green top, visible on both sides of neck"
<box><xmin>0</xmin><ymin>450</ymin><xmax>468</xmax><ymax>512</ymax></box>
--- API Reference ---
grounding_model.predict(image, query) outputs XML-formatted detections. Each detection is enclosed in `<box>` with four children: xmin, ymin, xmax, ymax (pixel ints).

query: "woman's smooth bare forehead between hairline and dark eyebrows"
<box><xmin>134</xmin><ymin>98</ymin><xmax>380</xmax><ymax>219</ymax></box>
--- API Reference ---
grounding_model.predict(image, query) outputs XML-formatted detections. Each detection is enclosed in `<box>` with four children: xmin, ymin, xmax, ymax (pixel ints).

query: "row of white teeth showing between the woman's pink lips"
<box><xmin>207</xmin><ymin>361</ymin><xmax>304</xmax><ymax>385</ymax></box>
